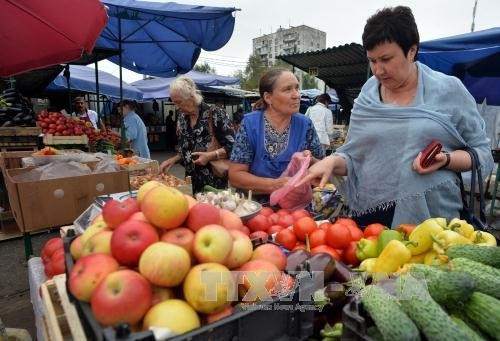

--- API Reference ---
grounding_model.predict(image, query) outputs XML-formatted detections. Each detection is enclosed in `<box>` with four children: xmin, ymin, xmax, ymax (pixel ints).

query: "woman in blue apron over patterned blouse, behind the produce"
<box><xmin>229</xmin><ymin>68</ymin><xmax>324</xmax><ymax>201</ymax></box>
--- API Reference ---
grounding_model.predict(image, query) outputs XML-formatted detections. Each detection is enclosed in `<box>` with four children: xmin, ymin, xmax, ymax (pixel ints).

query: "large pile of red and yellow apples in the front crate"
<box><xmin>64</xmin><ymin>181</ymin><xmax>295</xmax><ymax>334</ymax></box>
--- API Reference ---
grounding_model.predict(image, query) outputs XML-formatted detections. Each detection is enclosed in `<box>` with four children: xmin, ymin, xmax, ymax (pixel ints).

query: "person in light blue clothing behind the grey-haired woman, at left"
<box><xmin>118</xmin><ymin>100</ymin><xmax>151</xmax><ymax>159</ymax></box>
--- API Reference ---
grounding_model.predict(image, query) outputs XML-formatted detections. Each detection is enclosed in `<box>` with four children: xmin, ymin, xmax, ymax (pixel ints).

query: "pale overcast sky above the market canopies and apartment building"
<box><xmin>99</xmin><ymin>0</ymin><xmax>500</xmax><ymax>82</ymax></box>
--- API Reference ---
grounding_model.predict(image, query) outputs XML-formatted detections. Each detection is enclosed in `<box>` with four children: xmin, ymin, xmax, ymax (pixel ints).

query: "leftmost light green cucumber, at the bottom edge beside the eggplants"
<box><xmin>361</xmin><ymin>285</ymin><xmax>420</xmax><ymax>340</ymax></box>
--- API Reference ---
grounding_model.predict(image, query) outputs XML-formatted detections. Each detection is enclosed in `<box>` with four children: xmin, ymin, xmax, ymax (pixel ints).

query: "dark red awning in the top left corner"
<box><xmin>0</xmin><ymin>0</ymin><xmax>108</xmax><ymax>77</ymax></box>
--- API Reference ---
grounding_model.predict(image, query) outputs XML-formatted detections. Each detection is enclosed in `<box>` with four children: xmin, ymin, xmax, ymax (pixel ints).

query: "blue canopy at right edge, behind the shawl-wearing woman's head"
<box><xmin>418</xmin><ymin>27</ymin><xmax>500</xmax><ymax>105</ymax></box>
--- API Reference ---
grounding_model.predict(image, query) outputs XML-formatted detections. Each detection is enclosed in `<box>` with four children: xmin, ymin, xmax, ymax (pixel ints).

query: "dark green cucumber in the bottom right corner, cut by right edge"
<box><xmin>464</xmin><ymin>291</ymin><xmax>500</xmax><ymax>340</ymax></box>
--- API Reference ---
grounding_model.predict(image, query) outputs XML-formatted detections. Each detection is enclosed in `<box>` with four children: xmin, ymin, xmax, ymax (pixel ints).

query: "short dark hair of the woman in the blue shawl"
<box><xmin>362</xmin><ymin>6</ymin><xmax>420</xmax><ymax>60</ymax></box>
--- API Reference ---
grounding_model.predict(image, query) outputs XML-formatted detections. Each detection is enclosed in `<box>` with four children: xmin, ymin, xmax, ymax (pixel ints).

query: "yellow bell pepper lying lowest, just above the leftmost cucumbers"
<box><xmin>372</xmin><ymin>239</ymin><xmax>411</xmax><ymax>280</ymax></box>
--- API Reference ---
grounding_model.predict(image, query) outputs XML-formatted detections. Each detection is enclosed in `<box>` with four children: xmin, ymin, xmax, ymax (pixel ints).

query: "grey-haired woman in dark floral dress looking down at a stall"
<box><xmin>160</xmin><ymin>76</ymin><xmax>234</xmax><ymax>194</ymax></box>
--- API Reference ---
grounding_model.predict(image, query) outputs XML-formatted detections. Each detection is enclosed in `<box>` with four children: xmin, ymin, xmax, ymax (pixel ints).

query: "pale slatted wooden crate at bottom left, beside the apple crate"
<box><xmin>40</xmin><ymin>274</ymin><xmax>87</xmax><ymax>341</ymax></box>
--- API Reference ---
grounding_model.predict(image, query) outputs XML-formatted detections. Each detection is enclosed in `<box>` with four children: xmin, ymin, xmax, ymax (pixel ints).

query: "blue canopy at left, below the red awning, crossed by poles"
<box><xmin>47</xmin><ymin>65</ymin><xmax>142</xmax><ymax>101</ymax></box>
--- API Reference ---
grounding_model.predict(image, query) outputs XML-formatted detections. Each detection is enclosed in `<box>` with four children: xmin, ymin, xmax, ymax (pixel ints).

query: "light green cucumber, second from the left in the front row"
<box><xmin>396</xmin><ymin>275</ymin><xmax>467</xmax><ymax>341</ymax></box>
